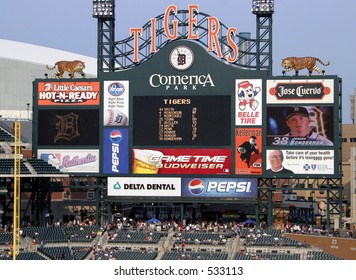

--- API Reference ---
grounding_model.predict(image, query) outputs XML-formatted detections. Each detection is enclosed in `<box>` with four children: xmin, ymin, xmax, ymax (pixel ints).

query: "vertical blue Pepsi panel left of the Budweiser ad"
<box><xmin>103</xmin><ymin>128</ymin><xmax>129</xmax><ymax>174</ymax></box>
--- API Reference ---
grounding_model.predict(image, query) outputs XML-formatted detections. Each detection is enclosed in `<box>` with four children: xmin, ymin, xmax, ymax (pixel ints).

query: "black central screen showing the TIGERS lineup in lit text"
<box><xmin>133</xmin><ymin>96</ymin><xmax>231</xmax><ymax>146</ymax></box>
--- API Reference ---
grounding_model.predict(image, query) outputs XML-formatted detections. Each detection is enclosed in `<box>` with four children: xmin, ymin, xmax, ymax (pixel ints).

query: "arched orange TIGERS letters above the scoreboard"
<box><xmin>130</xmin><ymin>4</ymin><xmax>239</xmax><ymax>63</ymax></box>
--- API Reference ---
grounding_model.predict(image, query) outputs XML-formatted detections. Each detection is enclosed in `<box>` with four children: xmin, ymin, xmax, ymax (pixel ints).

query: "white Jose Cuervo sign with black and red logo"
<box><xmin>267</xmin><ymin>80</ymin><xmax>334</xmax><ymax>103</ymax></box>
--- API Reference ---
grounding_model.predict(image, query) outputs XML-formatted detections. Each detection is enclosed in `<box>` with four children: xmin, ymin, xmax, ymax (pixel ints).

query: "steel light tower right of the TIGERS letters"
<box><xmin>252</xmin><ymin>0</ymin><xmax>274</xmax><ymax>74</ymax></box>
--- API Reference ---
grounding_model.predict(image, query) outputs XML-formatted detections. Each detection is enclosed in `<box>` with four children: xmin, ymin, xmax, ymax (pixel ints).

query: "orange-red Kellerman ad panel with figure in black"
<box><xmin>235</xmin><ymin>128</ymin><xmax>262</xmax><ymax>175</ymax></box>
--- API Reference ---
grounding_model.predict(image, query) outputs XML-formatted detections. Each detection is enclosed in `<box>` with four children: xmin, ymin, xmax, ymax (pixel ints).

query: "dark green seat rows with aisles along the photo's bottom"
<box><xmin>0</xmin><ymin>224</ymin><xmax>350</xmax><ymax>260</ymax></box>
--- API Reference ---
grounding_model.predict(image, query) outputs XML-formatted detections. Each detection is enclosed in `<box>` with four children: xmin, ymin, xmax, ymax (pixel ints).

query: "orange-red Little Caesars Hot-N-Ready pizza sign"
<box><xmin>38</xmin><ymin>82</ymin><xmax>100</xmax><ymax>106</ymax></box>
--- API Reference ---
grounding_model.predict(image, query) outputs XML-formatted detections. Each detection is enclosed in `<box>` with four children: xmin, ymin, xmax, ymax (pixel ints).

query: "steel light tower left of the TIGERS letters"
<box><xmin>93</xmin><ymin>0</ymin><xmax>115</xmax><ymax>76</ymax></box>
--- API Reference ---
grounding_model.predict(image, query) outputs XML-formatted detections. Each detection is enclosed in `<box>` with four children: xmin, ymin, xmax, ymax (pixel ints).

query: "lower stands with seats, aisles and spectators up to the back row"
<box><xmin>0</xmin><ymin>218</ymin><xmax>350</xmax><ymax>260</ymax></box>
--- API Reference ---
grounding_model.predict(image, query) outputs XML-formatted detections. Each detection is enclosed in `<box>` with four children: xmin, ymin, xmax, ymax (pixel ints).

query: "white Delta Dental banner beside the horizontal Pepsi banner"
<box><xmin>108</xmin><ymin>177</ymin><xmax>181</xmax><ymax>197</ymax></box>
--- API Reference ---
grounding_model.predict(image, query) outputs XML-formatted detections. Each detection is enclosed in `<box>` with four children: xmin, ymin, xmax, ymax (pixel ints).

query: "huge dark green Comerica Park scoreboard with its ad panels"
<box><xmin>33</xmin><ymin>40</ymin><xmax>341</xmax><ymax>197</ymax></box>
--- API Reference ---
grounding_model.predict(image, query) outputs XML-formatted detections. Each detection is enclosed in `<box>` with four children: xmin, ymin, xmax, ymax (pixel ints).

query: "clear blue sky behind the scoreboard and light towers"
<box><xmin>0</xmin><ymin>0</ymin><xmax>356</xmax><ymax>124</ymax></box>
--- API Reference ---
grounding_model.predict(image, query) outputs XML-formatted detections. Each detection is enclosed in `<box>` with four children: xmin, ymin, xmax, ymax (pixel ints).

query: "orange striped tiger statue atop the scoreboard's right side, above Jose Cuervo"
<box><xmin>282</xmin><ymin>56</ymin><xmax>330</xmax><ymax>76</ymax></box>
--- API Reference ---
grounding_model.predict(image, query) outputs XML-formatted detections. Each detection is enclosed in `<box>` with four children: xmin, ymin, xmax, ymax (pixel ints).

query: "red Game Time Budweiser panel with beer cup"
<box><xmin>132</xmin><ymin>149</ymin><xmax>231</xmax><ymax>175</ymax></box>
